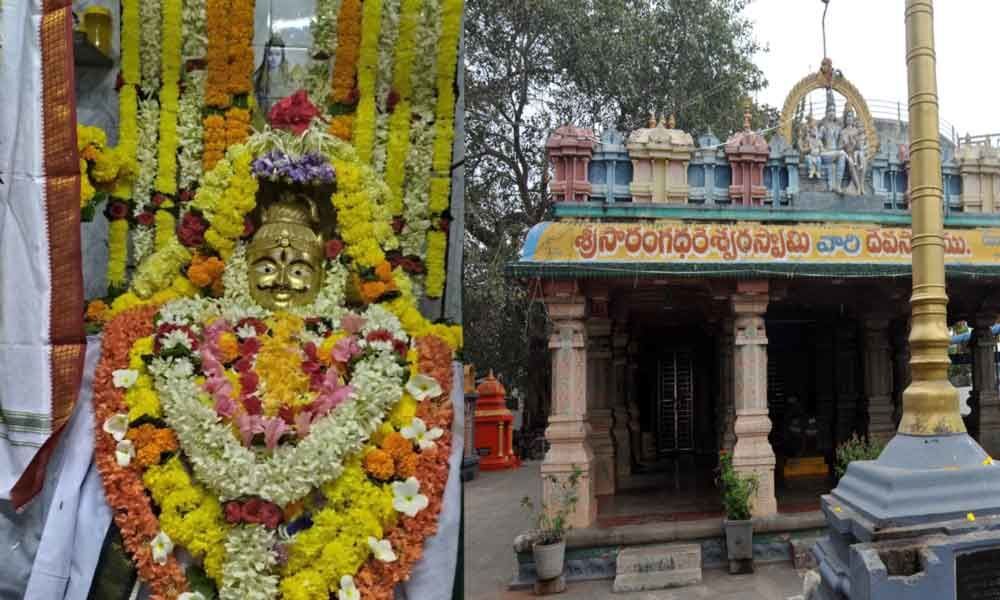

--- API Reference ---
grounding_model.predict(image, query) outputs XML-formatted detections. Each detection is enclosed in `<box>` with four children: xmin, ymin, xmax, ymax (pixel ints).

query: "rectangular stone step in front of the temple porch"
<box><xmin>612</xmin><ymin>544</ymin><xmax>701</xmax><ymax>592</ymax></box>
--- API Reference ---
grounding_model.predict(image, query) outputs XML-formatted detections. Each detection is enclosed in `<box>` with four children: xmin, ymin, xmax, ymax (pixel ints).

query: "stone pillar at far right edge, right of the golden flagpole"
<box><xmin>970</xmin><ymin>314</ymin><xmax>1000</xmax><ymax>456</ymax></box>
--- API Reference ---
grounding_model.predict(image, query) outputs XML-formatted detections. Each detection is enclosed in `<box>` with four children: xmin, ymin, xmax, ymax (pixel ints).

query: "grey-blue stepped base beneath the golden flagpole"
<box><xmin>813</xmin><ymin>434</ymin><xmax>1000</xmax><ymax>600</ymax></box>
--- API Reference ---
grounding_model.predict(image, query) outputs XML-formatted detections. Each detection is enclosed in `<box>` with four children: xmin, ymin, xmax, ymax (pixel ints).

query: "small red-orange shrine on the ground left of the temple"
<box><xmin>476</xmin><ymin>371</ymin><xmax>521</xmax><ymax>471</ymax></box>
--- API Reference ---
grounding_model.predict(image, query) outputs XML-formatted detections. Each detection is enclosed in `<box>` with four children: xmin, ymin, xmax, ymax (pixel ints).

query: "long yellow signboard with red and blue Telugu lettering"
<box><xmin>520</xmin><ymin>222</ymin><xmax>1000</xmax><ymax>265</ymax></box>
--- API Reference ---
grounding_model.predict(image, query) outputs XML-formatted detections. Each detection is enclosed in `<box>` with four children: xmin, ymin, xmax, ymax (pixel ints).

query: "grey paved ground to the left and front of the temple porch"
<box><xmin>464</xmin><ymin>462</ymin><xmax>802</xmax><ymax>600</ymax></box>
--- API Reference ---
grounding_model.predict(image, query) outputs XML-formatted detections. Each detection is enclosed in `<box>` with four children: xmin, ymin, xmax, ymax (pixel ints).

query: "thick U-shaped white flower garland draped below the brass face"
<box><xmin>149</xmin><ymin>305</ymin><xmax>406</xmax><ymax>506</ymax></box>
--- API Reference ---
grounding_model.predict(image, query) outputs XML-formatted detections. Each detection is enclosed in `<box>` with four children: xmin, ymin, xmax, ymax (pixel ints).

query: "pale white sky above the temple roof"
<box><xmin>745</xmin><ymin>0</ymin><xmax>1000</xmax><ymax>136</ymax></box>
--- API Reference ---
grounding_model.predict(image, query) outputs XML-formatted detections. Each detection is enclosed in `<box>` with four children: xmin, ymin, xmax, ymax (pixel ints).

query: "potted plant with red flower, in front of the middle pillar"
<box><xmin>719</xmin><ymin>452</ymin><xmax>757</xmax><ymax>574</ymax></box>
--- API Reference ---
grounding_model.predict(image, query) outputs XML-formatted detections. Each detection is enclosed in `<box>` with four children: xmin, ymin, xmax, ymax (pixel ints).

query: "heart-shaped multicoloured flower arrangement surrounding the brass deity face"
<box><xmin>94</xmin><ymin>123</ymin><xmax>461</xmax><ymax>600</ymax></box>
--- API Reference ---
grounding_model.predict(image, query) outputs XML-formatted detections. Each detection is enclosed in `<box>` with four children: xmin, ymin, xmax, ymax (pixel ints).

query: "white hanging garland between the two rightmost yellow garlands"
<box><xmin>399</xmin><ymin>0</ymin><xmax>441</xmax><ymax>260</ymax></box>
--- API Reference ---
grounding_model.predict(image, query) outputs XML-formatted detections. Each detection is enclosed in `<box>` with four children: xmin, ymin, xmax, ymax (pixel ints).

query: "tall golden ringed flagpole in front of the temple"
<box><xmin>899</xmin><ymin>0</ymin><xmax>965</xmax><ymax>435</ymax></box>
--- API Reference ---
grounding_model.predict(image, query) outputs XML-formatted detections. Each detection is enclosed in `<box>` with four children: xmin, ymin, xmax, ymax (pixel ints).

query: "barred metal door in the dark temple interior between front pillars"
<box><xmin>656</xmin><ymin>349</ymin><xmax>695</xmax><ymax>458</ymax></box>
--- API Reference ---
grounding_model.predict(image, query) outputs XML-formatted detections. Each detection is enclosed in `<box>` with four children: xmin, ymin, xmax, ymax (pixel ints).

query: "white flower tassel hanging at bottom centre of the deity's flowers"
<box><xmin>219</xmin><ymin>525</ymin><xmax>278</xmax><ymax>600</ymax></box>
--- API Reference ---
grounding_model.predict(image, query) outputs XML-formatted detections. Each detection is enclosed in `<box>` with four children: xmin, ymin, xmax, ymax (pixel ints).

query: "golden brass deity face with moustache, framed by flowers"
<box><xmin>247</xmin><ymin>196</ymin><xmax>324</xmax><ymax>310</ymax></box>
